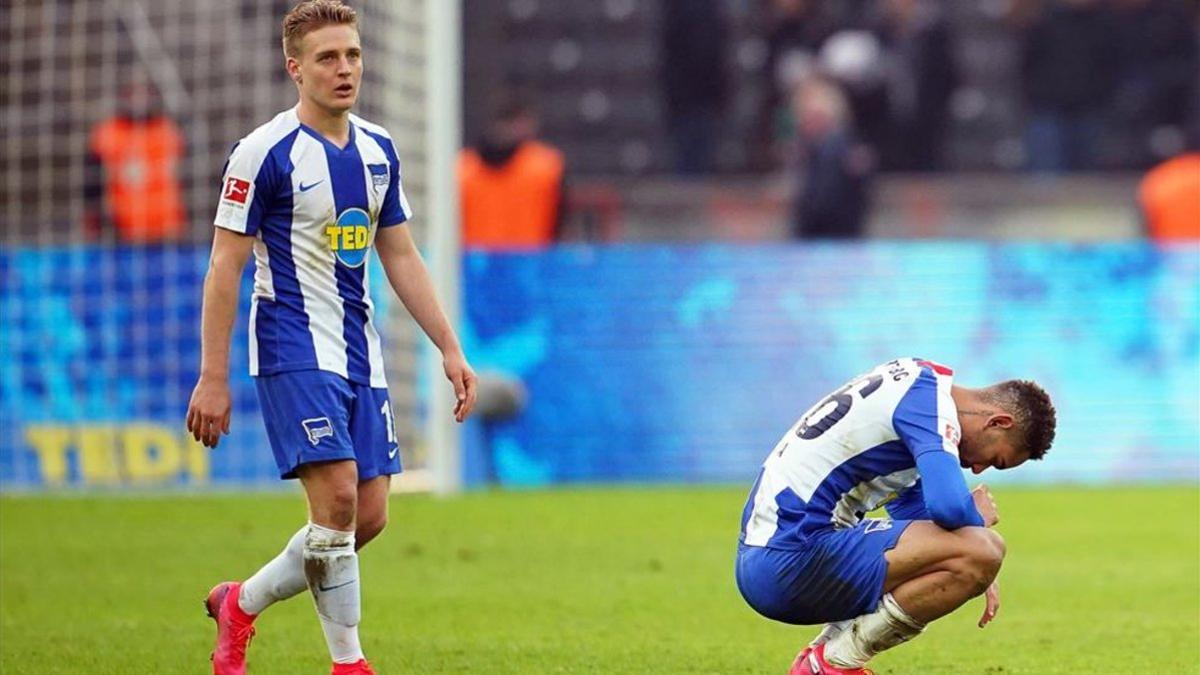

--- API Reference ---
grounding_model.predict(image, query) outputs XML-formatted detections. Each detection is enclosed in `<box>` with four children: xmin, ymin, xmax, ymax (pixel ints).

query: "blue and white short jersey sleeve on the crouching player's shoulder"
<box><xmin>892</xmin><ymin>366</ymin><xmax>960</xmax><ymax>458</ymax></box>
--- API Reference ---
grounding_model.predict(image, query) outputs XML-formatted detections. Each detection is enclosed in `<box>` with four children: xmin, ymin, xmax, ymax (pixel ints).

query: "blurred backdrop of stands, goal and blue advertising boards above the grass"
<box><xmin>0</xmin><ymin>0</ymin><xmax>1200</xmax><ymax>492</ymax></box>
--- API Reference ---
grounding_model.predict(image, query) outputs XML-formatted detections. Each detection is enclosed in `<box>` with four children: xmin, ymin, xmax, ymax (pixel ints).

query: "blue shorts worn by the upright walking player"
<box><xmin>254</xmin><ymin>370</ymin><xmax>401</xmax><ymax>480</ymax></box>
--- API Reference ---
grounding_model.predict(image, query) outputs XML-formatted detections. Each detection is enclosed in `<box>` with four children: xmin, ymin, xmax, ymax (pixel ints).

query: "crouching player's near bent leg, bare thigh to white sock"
<box><xmin>820</xmin><ymin>521</ymin><xmax>1004</xmax><ymax>668</ymax></box>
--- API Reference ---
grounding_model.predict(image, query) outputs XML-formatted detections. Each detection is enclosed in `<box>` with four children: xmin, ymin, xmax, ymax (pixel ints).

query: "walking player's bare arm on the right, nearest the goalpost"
<box><xmin>374</xmin><ymin>226</ymin><xmax>476</xmax><ymax>422</ymax></box>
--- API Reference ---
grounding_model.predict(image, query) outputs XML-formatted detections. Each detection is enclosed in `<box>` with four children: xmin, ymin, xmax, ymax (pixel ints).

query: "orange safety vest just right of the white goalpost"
<box><xmin>458</xmin><ymin>141</ymin><xmax>565</xmax><ymax>250</ymax></box>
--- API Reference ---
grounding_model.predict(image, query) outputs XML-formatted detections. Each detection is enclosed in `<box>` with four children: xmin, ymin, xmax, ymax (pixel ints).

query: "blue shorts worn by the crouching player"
<box><xmin>737</xmin><ymin>519</ymin><xmax>912</xmax><ymax>625</ymax></box>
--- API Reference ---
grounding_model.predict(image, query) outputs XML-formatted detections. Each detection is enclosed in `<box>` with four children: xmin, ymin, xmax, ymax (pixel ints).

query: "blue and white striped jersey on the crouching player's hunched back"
<box><xmin>742</xmin><ymin>358</ymin><xmax>982</xmax><ymax>549</ymax></box>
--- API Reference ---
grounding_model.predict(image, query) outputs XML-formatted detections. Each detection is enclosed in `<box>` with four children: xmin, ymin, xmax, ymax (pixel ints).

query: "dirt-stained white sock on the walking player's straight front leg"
<box><xmin>304</xmin><ymin>524</ymin><xmax>362</xmax><ymax>663</ymax></box>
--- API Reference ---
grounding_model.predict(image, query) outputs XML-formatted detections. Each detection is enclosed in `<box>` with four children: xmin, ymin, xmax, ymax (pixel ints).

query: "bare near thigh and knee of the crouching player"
<box><xmin>883</xmin><ymin>520</ymin><xmax>1003</xmax><ymax>591</ymax></box>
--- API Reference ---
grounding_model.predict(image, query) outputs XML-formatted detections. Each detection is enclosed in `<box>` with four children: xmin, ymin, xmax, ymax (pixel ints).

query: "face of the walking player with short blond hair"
<box><xmin>288</xmin><ymin>25</ymin><xmax>362</xmax><ymax>113</ymax></box>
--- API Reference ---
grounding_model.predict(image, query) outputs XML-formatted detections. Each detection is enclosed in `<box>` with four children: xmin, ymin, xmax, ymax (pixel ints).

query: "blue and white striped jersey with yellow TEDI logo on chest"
<box><xmin>215</xmin><ymin>108</ymin><xmax>412</xmax><ymax>387</ymax></box>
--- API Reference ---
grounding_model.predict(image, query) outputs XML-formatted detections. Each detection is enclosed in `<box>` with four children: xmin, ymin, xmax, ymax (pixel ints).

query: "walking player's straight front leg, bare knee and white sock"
<box><xmin>296</xmin><ymin>460</ymin><xmax>364</xmax><ymax>663</ymax></box>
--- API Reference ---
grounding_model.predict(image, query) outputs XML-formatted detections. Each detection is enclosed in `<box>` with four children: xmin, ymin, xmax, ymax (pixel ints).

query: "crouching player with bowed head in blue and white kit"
<box><xmin>737</xmin><ymin>358</ymin><xmax>1055</xmax><ymax>675</ymax></box>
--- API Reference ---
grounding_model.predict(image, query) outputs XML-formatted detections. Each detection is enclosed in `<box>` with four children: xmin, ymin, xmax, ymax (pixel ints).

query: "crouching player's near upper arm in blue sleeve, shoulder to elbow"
<box><xmin>892</xmin><ymin>366</ymin><xmax>985</xmax><ymax>530</ymax></box>
